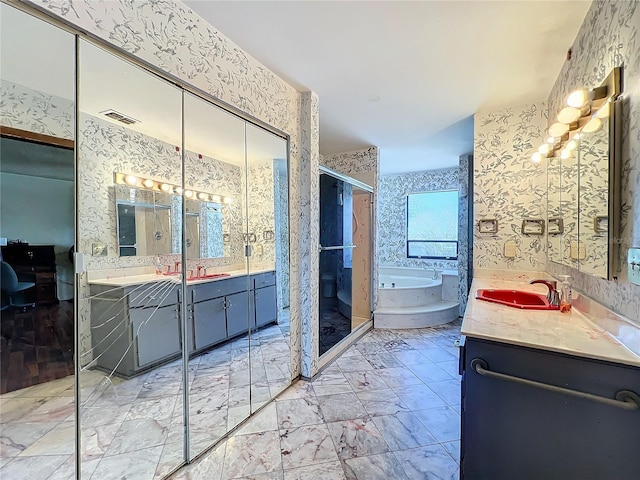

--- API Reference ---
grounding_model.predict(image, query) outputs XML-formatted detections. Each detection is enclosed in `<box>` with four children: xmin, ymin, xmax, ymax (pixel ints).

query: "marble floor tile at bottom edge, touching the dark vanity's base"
<box><xmin>394</xmin><ymin>445</ymin><xmax>460</xmax><ymax>480</ymax></box>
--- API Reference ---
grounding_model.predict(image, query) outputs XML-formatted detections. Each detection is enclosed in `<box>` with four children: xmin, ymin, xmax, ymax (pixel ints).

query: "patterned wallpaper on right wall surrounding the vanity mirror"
<box><xmin>548</xmin><ymin>0</ymin><xmax>640</xmax><ymax>322</ymax></box>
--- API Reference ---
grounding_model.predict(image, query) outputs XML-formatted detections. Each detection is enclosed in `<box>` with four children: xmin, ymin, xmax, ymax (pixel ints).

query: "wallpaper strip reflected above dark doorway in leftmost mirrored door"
<box><xmin>0</xmin><ymin>79</ymin><xmax>75</xmax><ymax>140</ymax></box>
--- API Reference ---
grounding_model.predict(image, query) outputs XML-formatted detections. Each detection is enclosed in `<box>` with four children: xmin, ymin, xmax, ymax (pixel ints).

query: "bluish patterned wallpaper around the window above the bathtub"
<box><xmin>377</xmin><ymin>167</ymin><xmax>458</xmax><ymax>270</ymax></box>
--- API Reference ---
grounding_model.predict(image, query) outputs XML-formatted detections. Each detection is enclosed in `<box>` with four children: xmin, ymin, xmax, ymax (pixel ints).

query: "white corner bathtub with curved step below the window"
<box><xmin>374</xmin><ymin>266</ymin><xmax>459</xmax><ymax>328</ymax></box>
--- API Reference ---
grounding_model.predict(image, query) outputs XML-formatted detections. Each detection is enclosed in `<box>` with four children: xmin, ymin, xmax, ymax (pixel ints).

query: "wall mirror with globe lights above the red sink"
<box><xmin>547</xmin><ymin>68</ymin><xmax>622</xmax><ymax>279</ymax></box>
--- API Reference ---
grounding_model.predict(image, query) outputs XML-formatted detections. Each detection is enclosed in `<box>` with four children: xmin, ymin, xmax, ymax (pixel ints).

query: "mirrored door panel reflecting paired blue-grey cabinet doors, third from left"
<box><xmin>184</xmin><ymin>93</ymin><xmax>251</xmax><ymax>458</ymax></box>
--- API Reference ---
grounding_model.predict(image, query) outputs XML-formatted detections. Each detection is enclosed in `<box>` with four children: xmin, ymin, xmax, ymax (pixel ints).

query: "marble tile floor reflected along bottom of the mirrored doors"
<box><xmin>0</xmin><ymin>310</ymin><xmax>291</xmax><ymax>480</ymax></box>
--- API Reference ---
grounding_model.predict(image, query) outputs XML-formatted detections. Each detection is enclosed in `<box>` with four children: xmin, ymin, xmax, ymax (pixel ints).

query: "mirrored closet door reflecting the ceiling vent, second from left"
<box><xmin>77</xmin><ymin>41</ymin><xmax>185</xmax><ymax>480</ymax></box>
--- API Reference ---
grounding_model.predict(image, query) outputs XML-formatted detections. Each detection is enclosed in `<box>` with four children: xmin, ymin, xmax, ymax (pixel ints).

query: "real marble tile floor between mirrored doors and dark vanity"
<box><xmin>171</xmin><ymin>321</ymin><xmax>460</xmax><ymax>480</ymax></box>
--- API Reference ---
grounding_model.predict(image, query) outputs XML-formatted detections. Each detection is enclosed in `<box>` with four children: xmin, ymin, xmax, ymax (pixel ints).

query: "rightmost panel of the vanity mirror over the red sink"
<box><xmin>578</xmin><ymin>114</ymin><xmax>609</xmax><ymax>278</ymax></box>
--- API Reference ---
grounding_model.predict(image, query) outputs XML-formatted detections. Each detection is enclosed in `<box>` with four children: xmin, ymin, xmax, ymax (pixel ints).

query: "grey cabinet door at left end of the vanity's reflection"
<box><xmin>129</xmin><ymin>305</ymin><xmax>180</xmax><ymax>367</ymax></box>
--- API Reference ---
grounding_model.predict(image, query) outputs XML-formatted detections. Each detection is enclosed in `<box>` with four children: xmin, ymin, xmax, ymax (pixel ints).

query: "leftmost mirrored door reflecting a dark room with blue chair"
<box><xmin>0</xmin><ymin>3</ymin><xmax>75</xmax><ymax>479</ymax></box>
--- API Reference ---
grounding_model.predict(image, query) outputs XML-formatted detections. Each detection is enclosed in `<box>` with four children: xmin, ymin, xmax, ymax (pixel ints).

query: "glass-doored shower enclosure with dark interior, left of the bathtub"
<box><xmin>318</xmin><ymin>167</ymin><xmax>373</xmax><ymax>356</ymax></box>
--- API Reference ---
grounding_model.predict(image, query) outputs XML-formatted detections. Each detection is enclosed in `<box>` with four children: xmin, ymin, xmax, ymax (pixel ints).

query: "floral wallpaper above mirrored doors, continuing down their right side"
<box><xmin>26</xmin><ymin>0</ymin><xmax>310</xmax><ymax>376</ymax></box>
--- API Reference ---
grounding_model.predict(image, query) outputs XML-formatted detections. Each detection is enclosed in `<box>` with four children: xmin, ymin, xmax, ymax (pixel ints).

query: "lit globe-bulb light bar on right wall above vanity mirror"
<box><xmin>531</xmin><ymin>67</ymin><xmax>621</xmax><ymax>163</ymax></box>
